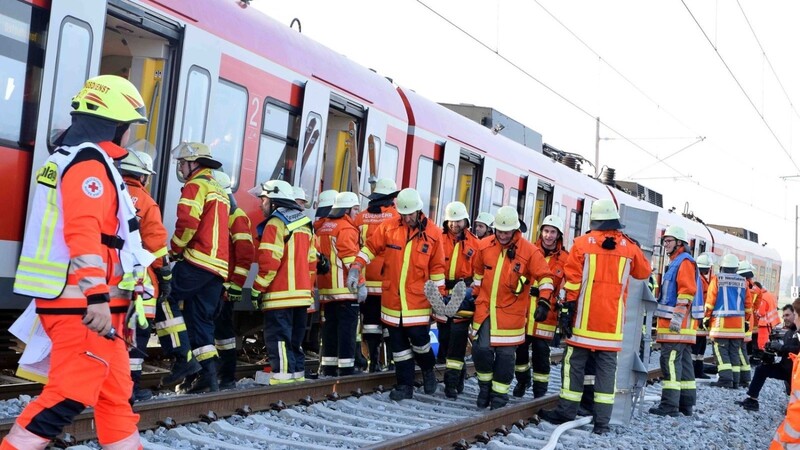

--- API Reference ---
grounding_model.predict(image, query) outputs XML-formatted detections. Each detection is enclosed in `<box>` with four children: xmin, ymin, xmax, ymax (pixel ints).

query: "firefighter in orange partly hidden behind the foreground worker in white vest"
<box><xmin>118</xmin><ymin>146</ymin><xmax>172</xmax><ymax>402</ymax></box>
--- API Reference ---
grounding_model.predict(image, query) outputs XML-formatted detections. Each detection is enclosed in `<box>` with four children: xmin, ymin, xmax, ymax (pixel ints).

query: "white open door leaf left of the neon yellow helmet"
<box><xmin>28</xmin><ymin>0</ymin><xmax>107</xmax><ymax>214</ymax></box>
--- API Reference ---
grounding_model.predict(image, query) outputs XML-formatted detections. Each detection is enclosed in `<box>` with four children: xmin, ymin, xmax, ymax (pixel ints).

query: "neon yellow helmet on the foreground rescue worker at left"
<box><xmin>71</xmin><ymin>75</ymin><xmax>147</xmax><ymax>123</ymax></box>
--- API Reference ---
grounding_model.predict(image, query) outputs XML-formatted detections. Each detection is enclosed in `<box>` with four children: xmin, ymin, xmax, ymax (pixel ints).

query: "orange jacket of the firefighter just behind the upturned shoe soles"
<box><xmin>433</xmin><ymin>229</ymin><xmax>480</xmax><ymax>323</ymax></box>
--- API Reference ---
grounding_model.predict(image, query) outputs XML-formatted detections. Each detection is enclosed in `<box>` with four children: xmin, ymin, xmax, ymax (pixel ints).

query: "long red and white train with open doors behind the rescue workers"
<box><xmin>0</xmin><ymin>0</ymin><xmax>780</xmax><ymax>324</ymax></box>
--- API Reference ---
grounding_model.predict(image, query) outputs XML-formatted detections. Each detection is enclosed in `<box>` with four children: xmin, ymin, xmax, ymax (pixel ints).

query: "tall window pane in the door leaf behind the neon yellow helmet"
<box><xmin>48</xmin><ymin>17</ymin><xmax>92</xmax><ymax>148</ymax></box>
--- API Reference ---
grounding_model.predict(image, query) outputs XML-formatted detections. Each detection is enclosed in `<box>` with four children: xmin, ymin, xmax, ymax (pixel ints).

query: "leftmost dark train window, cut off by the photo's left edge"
<box><xmin>0</xmin><ymin>2</ymin><xmax>45</xmax><ymax>148</ymax></box>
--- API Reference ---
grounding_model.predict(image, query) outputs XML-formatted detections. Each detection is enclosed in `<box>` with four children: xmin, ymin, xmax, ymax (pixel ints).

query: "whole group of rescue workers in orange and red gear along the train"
<box><xmin>0</xmin><ymin>75</ymin><xmax>800</xmax><ymax>449</ymax></box>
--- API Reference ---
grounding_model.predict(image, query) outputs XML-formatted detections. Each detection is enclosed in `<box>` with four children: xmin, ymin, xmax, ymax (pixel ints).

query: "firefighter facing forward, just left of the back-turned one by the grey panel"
<box><xmin>513</xmin><ymin>215</ymin><xmax>569</xmax><ymax>398</ymax></box>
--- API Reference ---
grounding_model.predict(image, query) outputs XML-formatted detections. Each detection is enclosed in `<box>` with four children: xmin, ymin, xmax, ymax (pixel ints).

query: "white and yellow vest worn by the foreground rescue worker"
<box><xmin>14</xmin><ymin>143</ymin><xmax>155</xmax><ymax>299</ymax></box>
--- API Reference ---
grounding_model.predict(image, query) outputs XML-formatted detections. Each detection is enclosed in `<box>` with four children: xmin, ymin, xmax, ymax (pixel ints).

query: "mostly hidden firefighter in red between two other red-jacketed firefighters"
<box><xmin>214</xmin><ymin>170</ymin><xmax>256</xmax><ymax>390</ymax></box>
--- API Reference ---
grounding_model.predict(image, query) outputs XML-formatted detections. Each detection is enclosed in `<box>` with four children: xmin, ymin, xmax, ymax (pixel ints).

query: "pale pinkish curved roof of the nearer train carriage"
<box><xmin>148</xmin><ymin>0</ymin><xmax>406</xmax><ymax>121</ymax></box>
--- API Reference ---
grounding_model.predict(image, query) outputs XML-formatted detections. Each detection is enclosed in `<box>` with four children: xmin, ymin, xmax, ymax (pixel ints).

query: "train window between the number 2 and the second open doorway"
<box><xmin>256</xmin><ymin>101</ymin><xmax>300</xmax><ymax>183</ymax></box>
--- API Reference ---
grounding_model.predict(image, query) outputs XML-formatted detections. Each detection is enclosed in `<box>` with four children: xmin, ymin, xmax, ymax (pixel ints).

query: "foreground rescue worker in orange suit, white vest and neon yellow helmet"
<box><xmin>0</xmin><ymin>75</ymin><xmax>153</xmax><ymax>450</ymax></box>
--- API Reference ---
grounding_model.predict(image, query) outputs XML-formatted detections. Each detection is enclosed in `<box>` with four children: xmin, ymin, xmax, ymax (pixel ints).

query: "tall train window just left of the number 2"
<box><xmin>206</xmin><ymin>80</ymin><xmax>247</xmax><ymax>191</ymax></box>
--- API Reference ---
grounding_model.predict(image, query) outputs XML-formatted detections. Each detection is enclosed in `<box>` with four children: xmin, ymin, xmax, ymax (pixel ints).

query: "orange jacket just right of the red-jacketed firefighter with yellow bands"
<box><xmin>316</xmin><ymin>215</ymin><xmax>361</xmax><ymax>302</ymax></box>
